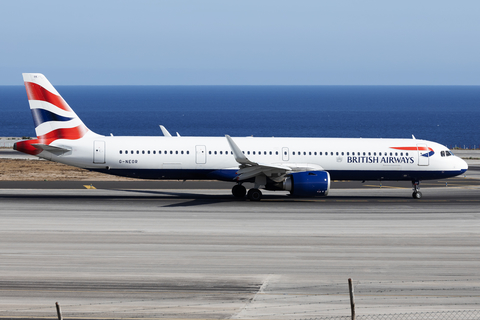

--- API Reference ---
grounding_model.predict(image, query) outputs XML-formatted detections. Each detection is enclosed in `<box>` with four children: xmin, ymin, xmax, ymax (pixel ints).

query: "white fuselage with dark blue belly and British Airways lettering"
<box><xmin>39</xmin><ymin>136</ymin><xmax>467</xmax><ymax>181</ymax></box>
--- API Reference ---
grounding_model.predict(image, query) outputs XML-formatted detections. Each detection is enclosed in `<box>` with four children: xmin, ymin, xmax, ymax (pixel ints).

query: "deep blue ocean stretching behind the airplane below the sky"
<box><xmin>0</xmin><ymin>86</ymin><xmax>480</xmax><ymax>148</ymax></box>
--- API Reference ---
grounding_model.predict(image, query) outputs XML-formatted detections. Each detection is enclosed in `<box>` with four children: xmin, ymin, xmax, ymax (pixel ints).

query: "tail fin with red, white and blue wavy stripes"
<box><xmin>23</xmin><ymin>73</ymin><xmax>97</xmax><ymax>145</ymax></box>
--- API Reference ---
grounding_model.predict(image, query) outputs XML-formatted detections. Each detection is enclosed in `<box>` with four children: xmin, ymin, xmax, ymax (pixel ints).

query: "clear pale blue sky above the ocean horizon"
<box><xmin>0</xmin><ymin>0</ymin><xmax>480</xmax><ymax>85</ymax></box>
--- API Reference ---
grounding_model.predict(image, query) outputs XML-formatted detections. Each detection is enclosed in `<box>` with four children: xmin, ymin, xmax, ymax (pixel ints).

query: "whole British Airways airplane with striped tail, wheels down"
<box><xmin>14</xmin><ymin>73</ymin><xmax>468</xmax><ymax>201</ymax></box>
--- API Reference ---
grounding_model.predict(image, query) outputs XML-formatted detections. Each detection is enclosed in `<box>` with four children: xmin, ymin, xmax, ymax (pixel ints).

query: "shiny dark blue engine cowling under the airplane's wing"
<box><xmin>283</xmin><ymin>171</ymin><xmax>330</xmax><ymax>197</ymax></box>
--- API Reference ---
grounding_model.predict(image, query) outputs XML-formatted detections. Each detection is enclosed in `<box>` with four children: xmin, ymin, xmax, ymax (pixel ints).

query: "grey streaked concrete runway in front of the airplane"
<box><xmin>0</xmin><ymin>184</ymin><xmax>480</xmax><ymax>319</ymax></box>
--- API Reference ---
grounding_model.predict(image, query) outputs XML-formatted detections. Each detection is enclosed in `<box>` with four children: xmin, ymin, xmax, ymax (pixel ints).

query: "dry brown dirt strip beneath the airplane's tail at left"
<box><xmin>0</xmin><ymin>159</ymin><xmax>138</xmax><ymax>181</ymax></box>
